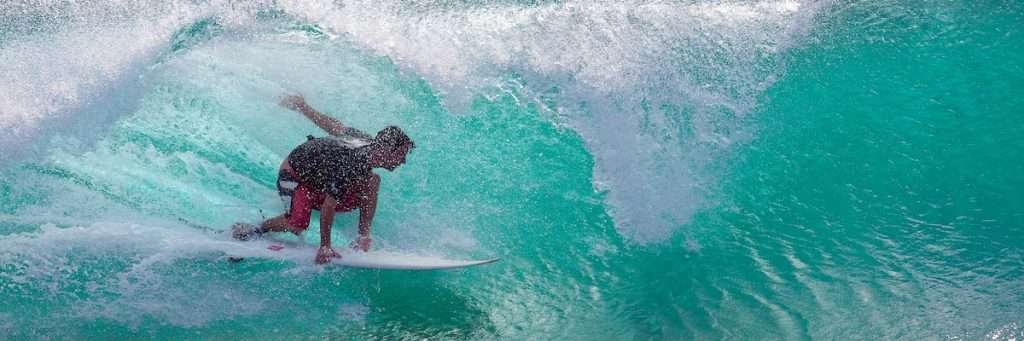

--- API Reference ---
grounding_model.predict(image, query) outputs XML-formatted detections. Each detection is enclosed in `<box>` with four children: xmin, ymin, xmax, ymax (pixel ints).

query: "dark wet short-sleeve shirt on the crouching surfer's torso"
<box><xmin>288</xmin><ymin>137</ymin><xmax>373</xmax><ymax>200</ymax></box>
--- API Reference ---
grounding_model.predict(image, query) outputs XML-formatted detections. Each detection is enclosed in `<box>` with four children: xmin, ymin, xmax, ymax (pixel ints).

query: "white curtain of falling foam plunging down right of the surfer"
<box><xmin>280</xmin><ymin>0</ymin><xmax>821</xmax><ymax>242</ymax></box>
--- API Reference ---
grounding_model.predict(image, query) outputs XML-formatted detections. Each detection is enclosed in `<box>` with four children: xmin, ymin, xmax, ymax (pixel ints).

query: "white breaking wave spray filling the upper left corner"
<box><xmin>0</xmin><ymin>0</ymin><xmax>268</xmax><ymax>162</ymax></box>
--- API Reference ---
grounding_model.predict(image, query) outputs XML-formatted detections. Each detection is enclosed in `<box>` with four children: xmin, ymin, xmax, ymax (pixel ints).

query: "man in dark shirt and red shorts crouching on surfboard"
<box><xmin>232</xmin><ymin>95</ymin><xmax>415</xmax><ymax>264</ymax></box>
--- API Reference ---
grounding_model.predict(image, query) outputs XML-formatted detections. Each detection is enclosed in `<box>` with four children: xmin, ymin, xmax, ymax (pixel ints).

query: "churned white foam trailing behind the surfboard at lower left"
<box><xmin>0</xmin><ymin>222</ymin><xmax>296</xmax><ymax>327</ymax></box>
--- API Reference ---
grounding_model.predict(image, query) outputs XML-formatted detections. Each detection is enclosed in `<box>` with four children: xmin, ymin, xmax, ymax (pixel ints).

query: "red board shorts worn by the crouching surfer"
<box><xmin>278</xmin><ymin>169</ymin><xmax>359</xmax><ymax>229</ymax></box>
